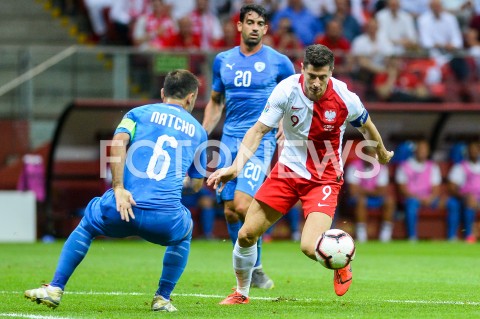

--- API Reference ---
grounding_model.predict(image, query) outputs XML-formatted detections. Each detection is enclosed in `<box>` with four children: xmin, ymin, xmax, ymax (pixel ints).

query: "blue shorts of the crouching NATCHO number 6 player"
<box><xmin>80</xmin><ymin>189</ymin><xmax>193</xmax><ymax>246</ymax></box>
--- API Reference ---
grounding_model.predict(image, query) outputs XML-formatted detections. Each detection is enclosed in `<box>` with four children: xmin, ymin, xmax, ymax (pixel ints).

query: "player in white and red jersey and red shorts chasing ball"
<box><xmin>207</xmin><ymin>44</ymin><xmax>393</xmax><ymax>305</ymax></box>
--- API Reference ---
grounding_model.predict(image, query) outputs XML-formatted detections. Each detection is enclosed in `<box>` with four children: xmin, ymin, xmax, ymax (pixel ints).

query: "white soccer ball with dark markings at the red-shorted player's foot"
<box><xmin>315</xmin><ymin>229</ymin><xmax>355</xmax><ymax>269</ymax></box>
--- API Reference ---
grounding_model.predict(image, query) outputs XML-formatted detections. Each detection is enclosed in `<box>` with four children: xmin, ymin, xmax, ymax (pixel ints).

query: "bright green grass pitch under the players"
<box><xmin>0</xmin><ymin>240</ymin><xmax>480</xmax><ymax>319</ymax></box>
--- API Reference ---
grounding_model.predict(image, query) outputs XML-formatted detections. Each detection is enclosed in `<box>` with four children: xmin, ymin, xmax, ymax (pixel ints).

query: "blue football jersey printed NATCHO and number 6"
<box><xmin>115</xmin><ymin>103</ymin><xmax>207</xmax><ymax>209</ymax></box>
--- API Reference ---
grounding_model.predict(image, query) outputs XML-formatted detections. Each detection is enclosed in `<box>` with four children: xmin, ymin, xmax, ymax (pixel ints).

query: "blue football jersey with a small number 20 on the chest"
<box><xmin>212</xmin><ymin>45</ymin><xmax>295</xmax><ymax>138</ymax></box>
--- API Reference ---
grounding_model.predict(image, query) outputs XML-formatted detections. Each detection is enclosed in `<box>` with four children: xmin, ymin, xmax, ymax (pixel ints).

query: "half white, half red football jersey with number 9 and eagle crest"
<box><xmin>259</xmin><ymin>74</ymin><xmax>368</xmax><ymax>182</ymax></box>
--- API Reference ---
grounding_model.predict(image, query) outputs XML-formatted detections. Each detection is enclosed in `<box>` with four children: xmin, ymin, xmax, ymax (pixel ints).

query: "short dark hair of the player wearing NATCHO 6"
<box><xmin>163</xmin><ymin>69</ymin><xmax>200</xmax><ymax>99</ymax></box>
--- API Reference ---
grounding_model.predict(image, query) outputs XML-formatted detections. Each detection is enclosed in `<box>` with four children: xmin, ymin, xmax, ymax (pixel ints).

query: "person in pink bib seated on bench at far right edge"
<box><xmin>447</xmin><ymin>141</ymin><xmax>480</xmax><ymax>243</ymax></box>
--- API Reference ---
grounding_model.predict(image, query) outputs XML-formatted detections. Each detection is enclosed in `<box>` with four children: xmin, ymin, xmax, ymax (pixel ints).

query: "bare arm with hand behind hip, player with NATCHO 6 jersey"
<box><xmin>110</xmin><ymin>133</ymin><xmax>136</xmax><ymax>222</ymax></box>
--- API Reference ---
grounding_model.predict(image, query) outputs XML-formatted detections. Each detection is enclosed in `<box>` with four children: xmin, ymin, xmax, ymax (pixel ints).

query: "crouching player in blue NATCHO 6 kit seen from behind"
<box><xmin>25</xmin><ymin>70</ymin><xmax>207</xmax><ymax>312</ymax></box>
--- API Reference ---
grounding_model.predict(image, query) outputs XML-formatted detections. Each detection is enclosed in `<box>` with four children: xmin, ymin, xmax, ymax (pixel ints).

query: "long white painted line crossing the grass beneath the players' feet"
<box><xmin>0</xmin><ymin>290</ymin><xmax>480</xmax><ymax>306</ymax></box>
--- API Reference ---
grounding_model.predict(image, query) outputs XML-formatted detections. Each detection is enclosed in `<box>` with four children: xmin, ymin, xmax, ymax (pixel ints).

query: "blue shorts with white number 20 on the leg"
<box><xmin>217</xmin><ymin>134</ymin><xmax>276</xmax><ymax>203</ymax></box>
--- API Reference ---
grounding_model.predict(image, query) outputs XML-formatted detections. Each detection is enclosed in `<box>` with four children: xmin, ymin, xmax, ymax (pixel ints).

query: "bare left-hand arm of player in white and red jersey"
<box><xmin>207</xmin><ymin>121</ymin><xmax>273</xmax><ymax>190</ymax></box>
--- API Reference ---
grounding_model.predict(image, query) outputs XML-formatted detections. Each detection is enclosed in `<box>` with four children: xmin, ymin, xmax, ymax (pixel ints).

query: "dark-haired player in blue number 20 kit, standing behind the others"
<box><xmin>203</xmin><ymin>4</ymin><xmax>295</xmax><ymax>289</ymax></box>
